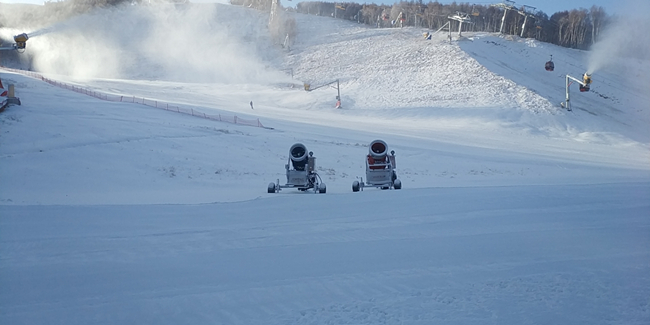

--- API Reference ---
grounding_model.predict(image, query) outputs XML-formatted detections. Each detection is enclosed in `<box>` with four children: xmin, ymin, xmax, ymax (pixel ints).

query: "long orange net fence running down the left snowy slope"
<box><xmin>2</xmin><ymin>67</ymin><xmax>272</xmax><ymax>129</ymax></box>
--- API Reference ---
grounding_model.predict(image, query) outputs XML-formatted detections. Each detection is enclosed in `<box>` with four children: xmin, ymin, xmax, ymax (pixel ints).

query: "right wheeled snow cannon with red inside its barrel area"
<box><xmin>352</xmin><ymin>140</ymin><xmax>402</xmax><ymax>192</ymax></box>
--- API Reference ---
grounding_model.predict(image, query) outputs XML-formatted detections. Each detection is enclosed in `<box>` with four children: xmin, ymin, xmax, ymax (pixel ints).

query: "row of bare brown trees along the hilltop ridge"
<box><xmin>294</xmin><ymin>0</ymin><xmax>611</xmax><ymax>49</ymax></box>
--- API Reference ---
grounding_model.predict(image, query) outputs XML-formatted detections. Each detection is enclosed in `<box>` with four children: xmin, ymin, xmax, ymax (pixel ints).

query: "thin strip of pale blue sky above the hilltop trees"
<box><xmin>0</xmin><ymin>0</ymin><xmax>616</xmax><ymax>16</ymax></box>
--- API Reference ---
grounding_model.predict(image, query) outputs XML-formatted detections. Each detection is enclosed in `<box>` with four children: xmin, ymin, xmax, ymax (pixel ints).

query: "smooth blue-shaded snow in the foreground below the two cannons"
<box><xmin>0</xmin><ymin>183</ymin><xmax>650</xmax><ymax>325</ymax></box>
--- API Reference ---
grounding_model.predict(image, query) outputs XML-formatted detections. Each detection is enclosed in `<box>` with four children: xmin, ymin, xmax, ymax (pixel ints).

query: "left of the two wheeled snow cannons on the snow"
<box><xmin>268</xmin><ymin>143</ymin><xmax>327</xmax><ymax>193</ymax></box>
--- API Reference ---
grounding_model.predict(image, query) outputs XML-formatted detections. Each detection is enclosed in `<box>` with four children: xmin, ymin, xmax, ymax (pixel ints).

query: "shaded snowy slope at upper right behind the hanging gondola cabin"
<box><xmin>459</xmin><ymin>35</ymin><xmax>650</xmax><ymax>143</ymax></box>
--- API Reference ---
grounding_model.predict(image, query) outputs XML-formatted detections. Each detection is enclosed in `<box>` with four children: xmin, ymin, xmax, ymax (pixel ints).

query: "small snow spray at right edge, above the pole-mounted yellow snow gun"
<box><xmin>587</xmin><ymin>0</ymin><xmax>650</xmax><ymax>74</ymax></box>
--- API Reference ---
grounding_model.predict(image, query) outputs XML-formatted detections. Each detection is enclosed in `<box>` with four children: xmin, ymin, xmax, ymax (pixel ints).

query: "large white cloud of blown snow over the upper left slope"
<box><xmin>23</xmin><ymin>4</ymin><xmax>290</xmax><ymax>83</ymax></box>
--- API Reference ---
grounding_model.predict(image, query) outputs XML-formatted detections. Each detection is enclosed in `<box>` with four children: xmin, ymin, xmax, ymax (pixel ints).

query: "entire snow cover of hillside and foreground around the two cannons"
<box><xmin>0</xmin><ymin>4</ymin><xmax>650</xmax><ymax>324</ymax></box>
